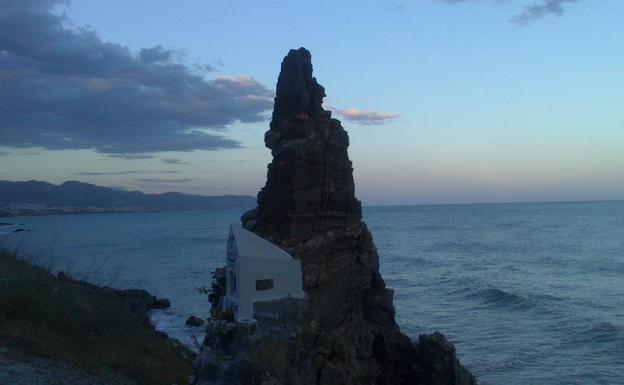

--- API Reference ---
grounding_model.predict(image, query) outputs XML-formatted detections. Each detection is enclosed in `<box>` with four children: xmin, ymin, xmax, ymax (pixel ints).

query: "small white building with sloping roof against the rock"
<box><xmin>223</xmin><ymin>223</ymin><xmax>304</xmax><ymax>321</ymax></box>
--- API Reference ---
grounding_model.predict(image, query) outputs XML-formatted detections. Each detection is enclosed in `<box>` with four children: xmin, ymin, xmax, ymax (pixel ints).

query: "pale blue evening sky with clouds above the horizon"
<box><xmin>0</xmin><ymin>0</ymin><xmax>624</xmax><ymax>205</ymax></box>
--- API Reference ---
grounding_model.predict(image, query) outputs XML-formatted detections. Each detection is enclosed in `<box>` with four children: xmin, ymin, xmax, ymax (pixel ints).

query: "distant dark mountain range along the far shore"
<box><xmin>0</xmin><ymin>181</ymin><xmax>256</xmax><ymax>215</ymax></box>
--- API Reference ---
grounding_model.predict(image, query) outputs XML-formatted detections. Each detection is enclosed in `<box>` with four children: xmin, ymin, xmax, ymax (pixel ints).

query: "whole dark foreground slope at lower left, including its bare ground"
<box><xmin>0</xmin><ymin>248</ymin><xmax>196</xmax><ymax>385</ymax></box>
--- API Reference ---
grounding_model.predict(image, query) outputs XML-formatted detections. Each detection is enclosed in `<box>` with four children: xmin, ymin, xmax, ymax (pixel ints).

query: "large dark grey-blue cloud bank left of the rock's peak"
<box><xmin>0</xmin><ymin>0</ymin><xmax>274</xmax><ymax>159</ymax></box>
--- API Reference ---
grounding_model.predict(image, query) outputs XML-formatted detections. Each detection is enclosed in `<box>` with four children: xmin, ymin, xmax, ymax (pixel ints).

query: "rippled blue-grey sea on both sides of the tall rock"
<box><xmin>0</xmin><ymin>202</ymin><xmax>624</xmax><ymax>385</ymax></box>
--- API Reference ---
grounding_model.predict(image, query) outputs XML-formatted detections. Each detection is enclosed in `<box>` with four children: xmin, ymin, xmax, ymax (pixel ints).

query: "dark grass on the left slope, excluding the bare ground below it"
<box><xmin>0</xmin><ymin>250</ymin><xmax>192</xmax><ymax>385</ymax></box>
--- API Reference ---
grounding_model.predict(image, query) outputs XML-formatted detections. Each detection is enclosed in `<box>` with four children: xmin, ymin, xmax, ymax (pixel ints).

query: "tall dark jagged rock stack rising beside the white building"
<box><xmin>242</xmin><ymin>48</ymin><xmax>475</xmax><ymax>385</ymax></box>
